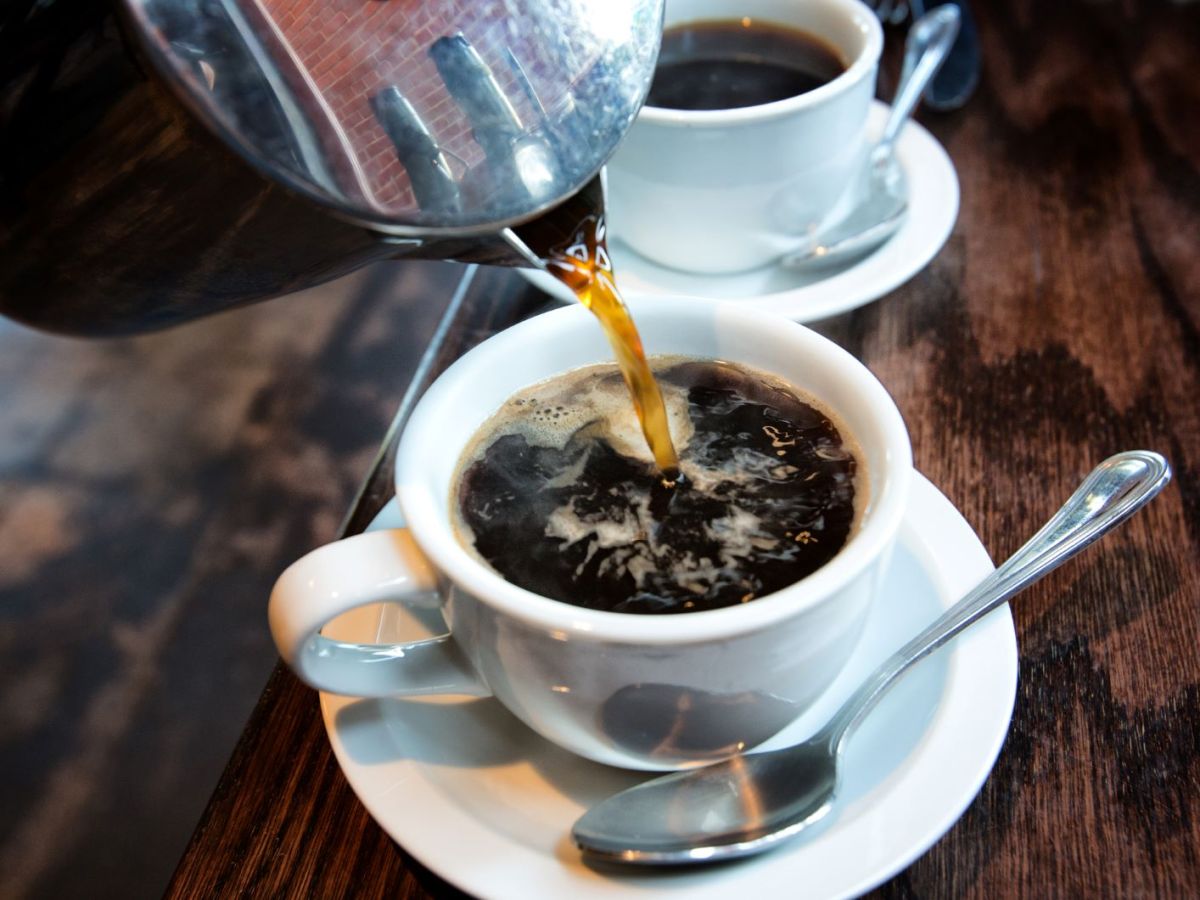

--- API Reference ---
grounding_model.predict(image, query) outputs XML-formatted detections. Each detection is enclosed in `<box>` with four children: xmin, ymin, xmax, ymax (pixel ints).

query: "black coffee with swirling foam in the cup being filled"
<box><xmin>454</xmin><ymin>358</ymin><xmax>865</xmax><ymax>613</ymax></box>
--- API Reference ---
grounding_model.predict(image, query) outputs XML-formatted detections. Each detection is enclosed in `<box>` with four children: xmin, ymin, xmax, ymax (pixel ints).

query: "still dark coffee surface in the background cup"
<box><xmin>646</xmin><ymin>19</ymin><xmax>846</xmax><ymax>109</ymax></box>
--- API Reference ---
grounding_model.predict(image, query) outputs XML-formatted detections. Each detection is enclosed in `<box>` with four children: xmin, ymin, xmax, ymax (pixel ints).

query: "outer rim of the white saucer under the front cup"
<box><xmin>320</xmin><ymin>470</ymin><xmax>1018</xmax><ymax>898</ymax></box>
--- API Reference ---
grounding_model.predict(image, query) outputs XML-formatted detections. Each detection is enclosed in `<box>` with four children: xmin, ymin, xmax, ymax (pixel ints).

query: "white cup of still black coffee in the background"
<box><xmin>607</xmin><ymin>0</ymin><xmax>883</xmax><ymax>274</ymax></box>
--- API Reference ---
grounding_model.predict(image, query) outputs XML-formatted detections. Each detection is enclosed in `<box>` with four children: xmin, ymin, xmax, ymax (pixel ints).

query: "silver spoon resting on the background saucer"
<box><xmin>780</xmin><ymin>6</ymin><xmax>959</xmax><ymax>269</ymax></box>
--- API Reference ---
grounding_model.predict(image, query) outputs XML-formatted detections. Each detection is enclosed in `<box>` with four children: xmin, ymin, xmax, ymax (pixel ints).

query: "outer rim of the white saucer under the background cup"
<box><xmin>517</xmin><ymin>100</ymin><xmax>961</xmax><ymax>323</ymax></box>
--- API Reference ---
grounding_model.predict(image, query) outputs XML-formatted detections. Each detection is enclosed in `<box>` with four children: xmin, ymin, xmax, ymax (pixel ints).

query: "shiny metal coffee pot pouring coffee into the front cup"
<box><xmin>0</xmin><ymin>0</ymin><xmax>662</xmax><ymax>335</ymax></box>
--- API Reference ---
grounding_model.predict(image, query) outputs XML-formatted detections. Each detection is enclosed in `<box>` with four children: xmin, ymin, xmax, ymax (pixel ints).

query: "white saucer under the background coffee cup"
<box><xmin>518</xmin><ymin>101</ymin><xmax>959</xmax><ymax>322</ymax></box>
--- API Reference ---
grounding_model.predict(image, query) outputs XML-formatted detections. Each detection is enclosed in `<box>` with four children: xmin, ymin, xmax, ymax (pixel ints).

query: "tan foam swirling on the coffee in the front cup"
<box><xmin>454</xmin><ymin>358</ymin><xmax>866</xmax><ymax>611</ymax></box>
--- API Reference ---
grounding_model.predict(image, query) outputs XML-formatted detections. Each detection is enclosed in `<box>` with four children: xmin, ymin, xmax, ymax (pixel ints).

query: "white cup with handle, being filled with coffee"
<box><xmin>270</xmin><ymin>298</ymin><xmax>912</xmax><ymax>769</ymax></box>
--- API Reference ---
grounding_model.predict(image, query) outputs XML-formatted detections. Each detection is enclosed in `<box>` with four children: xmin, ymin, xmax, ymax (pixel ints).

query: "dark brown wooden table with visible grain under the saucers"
<box><xmin>168</xmin><ymin>0</ymin><xmax>1200</xmax><ymax>898</ymax></box>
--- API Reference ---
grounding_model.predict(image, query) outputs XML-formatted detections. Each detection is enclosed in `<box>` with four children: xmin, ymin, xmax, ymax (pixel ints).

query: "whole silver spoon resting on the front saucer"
<box><xmin>572</xmin><ymin>450</ymin><xmax>1171</xmax><ymax>865</ymax></box>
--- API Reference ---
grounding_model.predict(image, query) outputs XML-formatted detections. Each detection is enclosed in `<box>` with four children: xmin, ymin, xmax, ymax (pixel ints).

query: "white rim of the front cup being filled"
<box><xmin>395</xmin><ymin>298</ymin><xmax>912</xmax><ymax>644</ymax></box>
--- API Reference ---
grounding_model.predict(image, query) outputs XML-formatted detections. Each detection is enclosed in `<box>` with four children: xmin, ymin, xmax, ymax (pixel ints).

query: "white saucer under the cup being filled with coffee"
<box><xmin>320</xmin><ymin>475</ymin><xmax>1016</xmax><ymax>900</ymax></box>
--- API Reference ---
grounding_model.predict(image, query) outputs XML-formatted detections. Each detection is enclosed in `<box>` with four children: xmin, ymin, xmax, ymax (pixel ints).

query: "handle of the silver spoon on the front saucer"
<box><xmin>818</xmin><ymin>450</ymin><xmax>1171</xmax><ymax>749</ymax></box>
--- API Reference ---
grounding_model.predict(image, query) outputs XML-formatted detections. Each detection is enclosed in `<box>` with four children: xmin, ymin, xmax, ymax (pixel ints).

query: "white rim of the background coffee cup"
<box><xmin>637</xmin><ymin>0</ymin><xmax>883</xmax><ymax>127</ymax></box>
